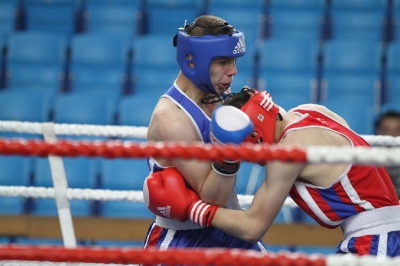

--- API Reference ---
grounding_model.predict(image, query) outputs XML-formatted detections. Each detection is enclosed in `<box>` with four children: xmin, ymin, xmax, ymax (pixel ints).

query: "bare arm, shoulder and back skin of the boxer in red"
<box><xmin>212</xmin><ymin>104</ymin><xmax>351</xmax><ymax>243</ymax></box>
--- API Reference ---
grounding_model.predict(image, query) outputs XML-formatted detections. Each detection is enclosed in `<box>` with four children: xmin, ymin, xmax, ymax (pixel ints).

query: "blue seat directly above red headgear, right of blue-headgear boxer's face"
<box><xmin>257</xmin><ymin>38</ymin><xmax>318</xmax><ymax>102</ymax></box>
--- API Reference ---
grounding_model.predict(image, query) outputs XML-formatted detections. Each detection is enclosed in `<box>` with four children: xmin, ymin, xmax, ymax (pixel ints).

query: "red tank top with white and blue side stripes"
<box><xmin>280</xmin><ymin>109</ymin><xmax>399</xmax><ymax>228</ymax></box>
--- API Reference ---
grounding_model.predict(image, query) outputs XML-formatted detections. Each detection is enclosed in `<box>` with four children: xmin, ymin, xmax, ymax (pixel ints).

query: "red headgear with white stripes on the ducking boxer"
<box><xmin>240</xmin><ymin>89</ymin><xmax>279</xmax><ymax>144</ymax></box>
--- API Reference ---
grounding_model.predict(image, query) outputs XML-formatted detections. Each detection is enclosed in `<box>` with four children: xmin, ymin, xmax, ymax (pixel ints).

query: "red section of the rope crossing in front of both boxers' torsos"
<box><xmin>0</xmin><ymin>139</ymin><xmax>307</xmax><ymax>163</ymax></box>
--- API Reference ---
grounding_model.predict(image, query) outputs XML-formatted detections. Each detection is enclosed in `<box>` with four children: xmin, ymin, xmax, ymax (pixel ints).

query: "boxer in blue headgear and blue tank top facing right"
<box><xmin>143</xmin><ymin>15</ymin><xmax>264</xmax><ymax>254</ymax></box>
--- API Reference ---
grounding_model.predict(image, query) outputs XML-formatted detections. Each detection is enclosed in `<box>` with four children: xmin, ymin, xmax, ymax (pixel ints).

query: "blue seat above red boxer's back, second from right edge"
<box><xmin>323</xmin><ymin>38</ymin><xmax>382</xmax><ymax>106</ymax></box>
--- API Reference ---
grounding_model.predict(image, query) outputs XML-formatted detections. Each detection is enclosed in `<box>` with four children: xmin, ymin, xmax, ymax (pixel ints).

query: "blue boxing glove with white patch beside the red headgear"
<box><xmin>210</xmin><ymin>105</ymin><xmax>254</xmax><ymax>176</ymax></box>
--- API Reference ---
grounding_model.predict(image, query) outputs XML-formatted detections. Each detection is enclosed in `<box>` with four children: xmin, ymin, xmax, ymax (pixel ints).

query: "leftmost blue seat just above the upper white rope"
<box><xmin>0</xmin><ymin>91</ymin><xmax>52</xmax><ymax>139</ymax></box>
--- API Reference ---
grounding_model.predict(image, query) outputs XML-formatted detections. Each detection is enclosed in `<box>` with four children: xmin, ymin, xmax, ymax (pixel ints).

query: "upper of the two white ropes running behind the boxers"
<box><xmin>0</xmin><ymin>120</ymin><xmax>400</xmax><ymax>147</ymax></box>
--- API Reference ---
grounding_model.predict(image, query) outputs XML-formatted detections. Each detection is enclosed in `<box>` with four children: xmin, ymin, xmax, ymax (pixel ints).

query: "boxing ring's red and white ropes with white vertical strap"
<box><xmin>0</xmin><ymin>121</ymin><xmax>400</xmax><ymax>266</ymax></box>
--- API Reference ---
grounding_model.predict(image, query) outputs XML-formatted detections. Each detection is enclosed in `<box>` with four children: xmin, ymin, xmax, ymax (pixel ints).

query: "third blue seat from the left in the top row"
<box><xmin>86</xmin><ymin>0</ymin><xmax>140</xmax><ymax>37</ymax></box>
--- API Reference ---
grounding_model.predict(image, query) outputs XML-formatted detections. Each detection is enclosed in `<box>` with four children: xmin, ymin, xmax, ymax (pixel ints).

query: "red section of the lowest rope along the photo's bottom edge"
<box><xmin>0</xmin><ymin>245</ymin><xmax>326</xmax><ymax>266</ymax></box>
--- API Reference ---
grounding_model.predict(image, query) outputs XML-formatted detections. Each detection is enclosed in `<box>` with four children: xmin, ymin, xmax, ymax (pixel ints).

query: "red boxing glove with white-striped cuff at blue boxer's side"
<box><xmin>143</xmin><ymin>167</ymin><xmax>218</xmax><ymax>227</ymax></box>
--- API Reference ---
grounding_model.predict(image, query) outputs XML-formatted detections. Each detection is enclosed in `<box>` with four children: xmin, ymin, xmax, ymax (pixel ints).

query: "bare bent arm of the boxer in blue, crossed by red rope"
<box><xmin>148</xmin><ymin>99</ymin><xmax>239</xmax><ymax>206</ymax></box>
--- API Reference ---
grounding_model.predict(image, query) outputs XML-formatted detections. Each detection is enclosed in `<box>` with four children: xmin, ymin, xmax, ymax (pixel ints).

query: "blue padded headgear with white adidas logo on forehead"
<box><xmin>173</xmin><ymin>22</ymin><xmax>246</xmax><ymax>98</ymax></box>
